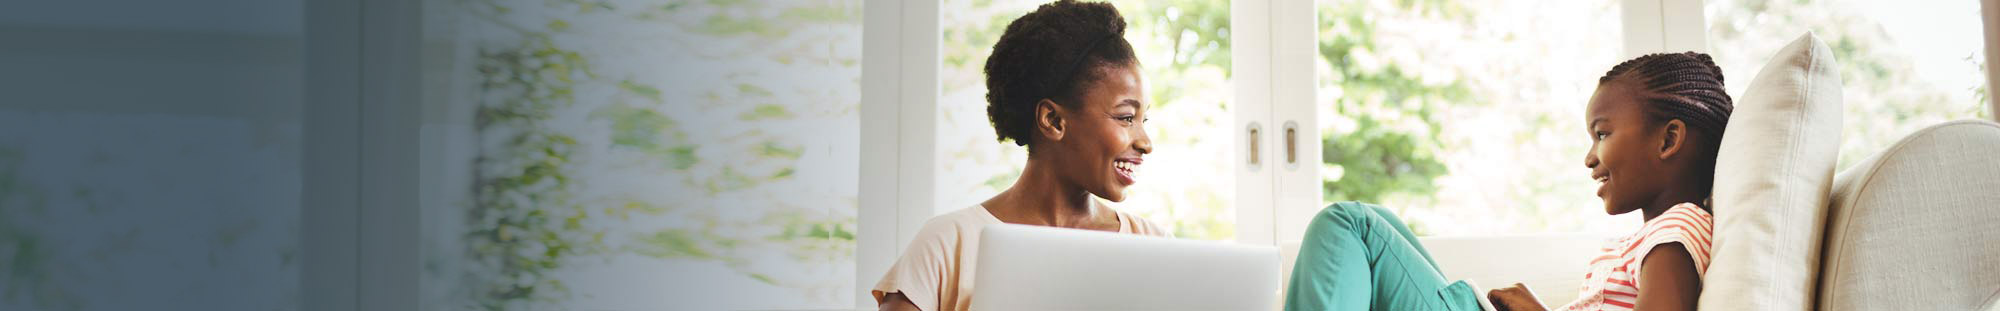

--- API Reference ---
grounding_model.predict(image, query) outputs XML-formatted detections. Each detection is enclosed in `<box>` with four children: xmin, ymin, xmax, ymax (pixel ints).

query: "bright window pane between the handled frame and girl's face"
<box><xmin>1314</xmin><ymin>0</ymin><xmax>1638</xmax><ymax>235</ymax></box>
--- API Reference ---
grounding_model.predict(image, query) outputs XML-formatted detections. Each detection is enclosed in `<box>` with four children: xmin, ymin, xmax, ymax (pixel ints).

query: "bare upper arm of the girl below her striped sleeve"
<box><xmin>1632</xmin><ymin>243</ymin><xmax>1702</xmax><ymax>311</ymax></box>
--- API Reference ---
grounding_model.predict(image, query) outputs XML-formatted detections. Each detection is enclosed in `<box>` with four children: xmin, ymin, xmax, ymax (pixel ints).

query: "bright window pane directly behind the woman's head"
<box><xmin>936</xmin><ymin>0</ymin><xmax>1236</xmax><ymax>239</ymax></box>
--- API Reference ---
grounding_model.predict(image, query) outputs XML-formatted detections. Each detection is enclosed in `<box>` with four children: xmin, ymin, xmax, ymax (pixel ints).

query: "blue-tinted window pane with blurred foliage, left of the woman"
<box><xmin>424</xmin><ymin>0</ymin><xmax>862</xmax><ymax>309</ymax></box>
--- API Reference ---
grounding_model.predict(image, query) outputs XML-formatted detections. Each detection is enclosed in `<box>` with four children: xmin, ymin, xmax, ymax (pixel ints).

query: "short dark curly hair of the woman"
<box><xmin>986</xmin><ymin>0</ymin><xmax>1138</xmax><ymax>146</ymax></box>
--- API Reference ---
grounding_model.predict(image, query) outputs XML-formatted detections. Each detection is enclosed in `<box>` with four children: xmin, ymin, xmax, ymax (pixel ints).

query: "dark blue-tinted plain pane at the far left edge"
<box><xmin>0</xmin><ymin>0</ymin><xmax>304</xmax><ymax>309</ymax></box>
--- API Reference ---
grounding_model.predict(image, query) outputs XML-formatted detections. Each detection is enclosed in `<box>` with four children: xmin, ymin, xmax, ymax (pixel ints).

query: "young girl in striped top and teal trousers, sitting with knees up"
<box><xmin>1286</xmin><ymin>52</ymin><xmax>1734</xmax><ymax>311</ymax></box>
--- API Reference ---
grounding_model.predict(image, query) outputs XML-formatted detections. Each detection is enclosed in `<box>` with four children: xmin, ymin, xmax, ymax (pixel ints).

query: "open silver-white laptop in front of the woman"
<box><xmin>972</xmin><ymin>223</ymin><xmax>1280</xmax><ymax>311</ymax></box>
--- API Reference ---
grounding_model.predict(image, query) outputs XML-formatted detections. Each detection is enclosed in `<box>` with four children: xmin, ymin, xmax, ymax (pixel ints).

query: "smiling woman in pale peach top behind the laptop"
<box><xmin>872</xmin><ymin>0</ymin><xmax>1166</xmax><ymax>311</ymax></box>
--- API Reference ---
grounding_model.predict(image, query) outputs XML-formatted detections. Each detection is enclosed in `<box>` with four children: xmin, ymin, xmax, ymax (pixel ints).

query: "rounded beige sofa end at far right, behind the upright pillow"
<box><xmin>1820</xmin><ymin>120</ymin><xmax>2000</xmax><ymax>311</ymax></box>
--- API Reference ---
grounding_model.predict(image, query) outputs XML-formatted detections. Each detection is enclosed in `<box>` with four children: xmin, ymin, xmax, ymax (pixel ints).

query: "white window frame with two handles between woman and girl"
<box><xmin>1230</xmin><ymin>2</ymin><xmax>1320</xmax><ymax>245</ymax></box>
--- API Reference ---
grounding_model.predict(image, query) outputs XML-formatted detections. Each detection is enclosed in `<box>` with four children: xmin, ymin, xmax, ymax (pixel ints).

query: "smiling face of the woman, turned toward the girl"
<box><xmin>1056</xmin><ymin>66</ymin><xmax>1152</xmax><ymax>201</ymax></box>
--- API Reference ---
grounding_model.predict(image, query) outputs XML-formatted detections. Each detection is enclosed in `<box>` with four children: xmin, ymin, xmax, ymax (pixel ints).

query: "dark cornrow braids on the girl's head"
<box><xmin>1598</xmin><ymin>52</ymin><xmax>1736</xmax><ymax>146</ymax></box>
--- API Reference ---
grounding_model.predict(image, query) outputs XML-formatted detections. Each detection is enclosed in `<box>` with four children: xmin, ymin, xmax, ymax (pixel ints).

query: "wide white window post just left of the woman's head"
<box><xmin>854</xmin><ymin>0</ymin><xmax>940</xmax><ymax>309</ymax></box>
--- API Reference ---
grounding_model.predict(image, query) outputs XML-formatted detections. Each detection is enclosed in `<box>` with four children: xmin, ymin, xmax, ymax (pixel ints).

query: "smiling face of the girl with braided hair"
<box><xmin>1584</xmin><ymin>80</ymin><xmax>1668</xmax><ymax>215</ymax></box>
